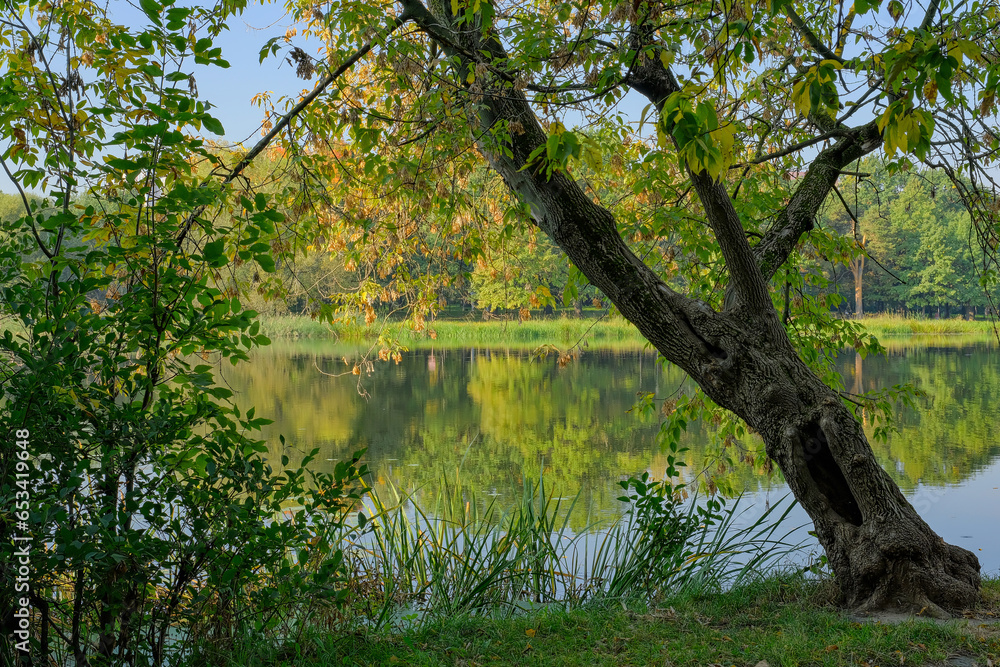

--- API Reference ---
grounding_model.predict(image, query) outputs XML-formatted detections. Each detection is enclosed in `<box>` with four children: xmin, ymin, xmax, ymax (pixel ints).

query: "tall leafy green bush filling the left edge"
<box><xmin>0</xmin><ymin>0</ymin><xmax>365</xmax><ymax>666</ymax></box>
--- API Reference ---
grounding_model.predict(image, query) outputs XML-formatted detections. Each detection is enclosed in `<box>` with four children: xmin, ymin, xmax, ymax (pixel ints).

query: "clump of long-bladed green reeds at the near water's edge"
<box><xmin>347</xmin><ymin>472</ymin><xmax>800</xmax><ymax>627</ymax></box>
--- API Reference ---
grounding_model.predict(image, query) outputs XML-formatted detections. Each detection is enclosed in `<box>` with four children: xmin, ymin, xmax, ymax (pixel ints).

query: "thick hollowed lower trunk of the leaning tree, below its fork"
<box><xmin>696</xmin><ymin>318</ymin><xmax>979</xmax><ymax>616</ymax></box>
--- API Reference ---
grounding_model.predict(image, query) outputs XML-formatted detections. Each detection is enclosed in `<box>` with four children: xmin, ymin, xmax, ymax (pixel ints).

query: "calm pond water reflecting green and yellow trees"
<box><xmin>223</xmin><ymin>339</ymin><xmax>1000</xmax><ymax>573</ymax></box>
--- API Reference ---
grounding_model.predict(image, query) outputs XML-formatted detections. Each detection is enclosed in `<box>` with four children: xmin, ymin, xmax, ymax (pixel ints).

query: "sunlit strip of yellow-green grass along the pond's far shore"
<box><xmin>259</xmin><ymin>313</ymin><xmax>1000</xmax><ymax>349</ymax></box>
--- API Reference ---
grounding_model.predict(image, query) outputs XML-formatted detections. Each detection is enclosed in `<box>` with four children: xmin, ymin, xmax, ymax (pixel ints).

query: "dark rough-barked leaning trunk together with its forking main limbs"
<box><xmin>402</xmin><ymin>0</ymin><xmax>979</xmax><ymax>615</ymax></box>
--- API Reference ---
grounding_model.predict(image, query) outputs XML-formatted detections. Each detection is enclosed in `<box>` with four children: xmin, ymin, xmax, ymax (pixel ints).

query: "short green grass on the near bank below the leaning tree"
<box><xmin>213</xmin><ymin>575</ymin><xmax>1000</xmax><ymax>667</ymax></box>
